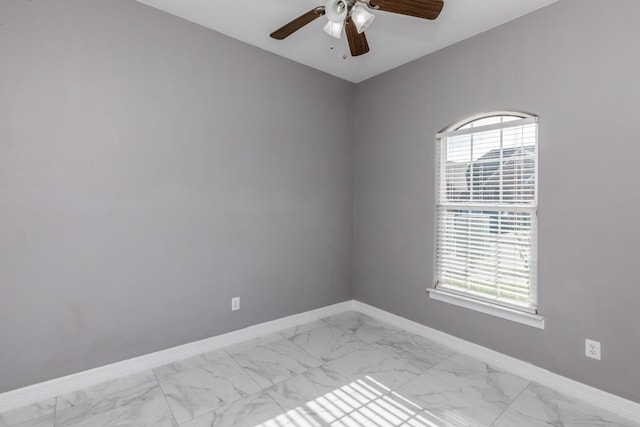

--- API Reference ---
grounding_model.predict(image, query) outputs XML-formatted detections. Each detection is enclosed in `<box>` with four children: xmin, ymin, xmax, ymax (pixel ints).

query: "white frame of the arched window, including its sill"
<box><xmin>427</xmin><ymin>111</ymin><xmax>544</xmax><ymax>329</ymax></box>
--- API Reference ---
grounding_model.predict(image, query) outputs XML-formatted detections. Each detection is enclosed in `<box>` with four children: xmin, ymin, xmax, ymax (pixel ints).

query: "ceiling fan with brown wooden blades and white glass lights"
<box><xmin>271</xmin><ymin>0</ymin><xmax>444</xmax><ymax>56</ymax></box>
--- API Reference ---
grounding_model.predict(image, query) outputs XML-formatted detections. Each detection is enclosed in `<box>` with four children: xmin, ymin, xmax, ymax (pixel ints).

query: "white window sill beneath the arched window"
<box><xmin>427</xmin><ymin>288</ymin><xmax>544</xmax><ymax>329</ymax></box>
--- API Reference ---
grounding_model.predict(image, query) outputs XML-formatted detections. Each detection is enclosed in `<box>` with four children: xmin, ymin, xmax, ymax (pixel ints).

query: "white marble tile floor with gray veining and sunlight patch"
<box><xmin>0</xmin><ymin>312</ymin><xmax>640</xmax><ymax>427</ymax></box>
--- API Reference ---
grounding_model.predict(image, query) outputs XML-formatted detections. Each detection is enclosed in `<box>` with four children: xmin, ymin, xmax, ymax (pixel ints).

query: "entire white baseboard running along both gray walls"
<box><xmin>0</xmin><ymin>301</ymin><xmax>640</xmax><ymax>420</ymax></box>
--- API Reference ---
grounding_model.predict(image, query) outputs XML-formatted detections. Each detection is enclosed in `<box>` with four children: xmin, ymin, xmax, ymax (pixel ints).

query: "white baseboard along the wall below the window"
<box><xmin>353</xmin><ymin>301</ymin><xmax>640</xmax><ymax>420</ymax></box>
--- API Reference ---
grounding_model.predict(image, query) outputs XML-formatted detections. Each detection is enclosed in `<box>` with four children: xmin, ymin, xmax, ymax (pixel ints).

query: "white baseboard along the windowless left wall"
<box><xmin>0</xmin><ymin>301</ymin><xmax>353</xmax><ymax>413</ymax></box>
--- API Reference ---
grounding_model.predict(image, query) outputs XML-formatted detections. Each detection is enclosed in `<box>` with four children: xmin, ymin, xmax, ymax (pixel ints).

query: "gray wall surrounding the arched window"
<box><xmin>354</xmin><ymin>0</ymin><xmax>640</xmax><ymax>401</ymax></box>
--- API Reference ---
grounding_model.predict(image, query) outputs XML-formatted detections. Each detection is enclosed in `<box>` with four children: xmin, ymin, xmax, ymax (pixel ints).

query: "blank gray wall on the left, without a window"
<box><xmin>0</xmin><ymin>0</ymin><xmax>354</xmax><ymax>392</ymax></box>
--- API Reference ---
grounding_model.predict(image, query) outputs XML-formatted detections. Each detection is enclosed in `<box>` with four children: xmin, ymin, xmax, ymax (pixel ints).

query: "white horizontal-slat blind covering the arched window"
<box><xmin>436</xmin><ymin>115</ymin><xmax>538</xmax><ymax>313</ymax></box>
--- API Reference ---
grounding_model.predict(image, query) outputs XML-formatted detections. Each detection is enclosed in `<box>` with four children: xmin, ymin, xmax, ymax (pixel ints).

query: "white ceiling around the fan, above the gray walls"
<box><xmin>138</xmin><ymin>0</ymin><xmax>557</xmax><ymax>83</ymax></box>
